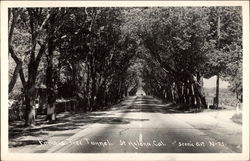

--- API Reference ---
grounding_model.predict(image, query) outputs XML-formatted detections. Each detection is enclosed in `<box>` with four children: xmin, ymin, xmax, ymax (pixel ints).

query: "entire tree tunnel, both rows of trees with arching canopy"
<box><xmin>9</xmin><ymin>7</ymin><xmax>242</xmax><ymax>125</ymax></box>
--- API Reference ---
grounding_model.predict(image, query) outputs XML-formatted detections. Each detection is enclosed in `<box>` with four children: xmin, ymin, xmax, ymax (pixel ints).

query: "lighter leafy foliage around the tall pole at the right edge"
<box><xmin>205</xmin><ymin>7</ymin><xmax>242</xmax><ymax>95</ymax></box>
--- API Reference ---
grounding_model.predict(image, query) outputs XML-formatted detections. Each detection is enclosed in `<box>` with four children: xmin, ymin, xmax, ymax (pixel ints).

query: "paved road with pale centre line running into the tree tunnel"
<box><xmin>48</xmin><ymin>96</ymin><xmax>241</xmax><ymax>153</ymax></box>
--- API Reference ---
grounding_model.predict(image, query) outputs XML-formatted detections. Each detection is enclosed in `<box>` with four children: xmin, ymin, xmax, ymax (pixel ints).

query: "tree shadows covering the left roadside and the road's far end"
<box><xmin>9</xmin><ymin>96</ymin><xmax>193</xmax><ymax>147</ymax></box>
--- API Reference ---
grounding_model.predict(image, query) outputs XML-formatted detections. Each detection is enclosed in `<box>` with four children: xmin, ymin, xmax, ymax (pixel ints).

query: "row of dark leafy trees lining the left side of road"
<box><xmin>9</xmin><ymin>8</ymin><xmax>138</xmax><ymax>125</ymax></box>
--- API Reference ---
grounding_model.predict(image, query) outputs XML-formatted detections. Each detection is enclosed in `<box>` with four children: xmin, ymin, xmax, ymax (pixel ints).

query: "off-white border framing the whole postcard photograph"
<box><xmin>1</xmin><ymin>1</ymin><xmax>250</xmax><ymax>161</ymax></box>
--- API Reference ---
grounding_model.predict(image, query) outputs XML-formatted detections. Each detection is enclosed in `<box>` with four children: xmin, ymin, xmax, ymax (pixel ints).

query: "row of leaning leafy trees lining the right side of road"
<box><xmin>124</xmin><ymin>7</ymin><xmax>242</xmax><ymax>108</ymax></box>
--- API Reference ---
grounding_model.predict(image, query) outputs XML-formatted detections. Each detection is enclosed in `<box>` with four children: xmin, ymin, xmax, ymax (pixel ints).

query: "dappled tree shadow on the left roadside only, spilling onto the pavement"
<box><xmin>9</xmin><ymin>96</ymin><xmax>141</xmax><ymax>147</ymax></box>
